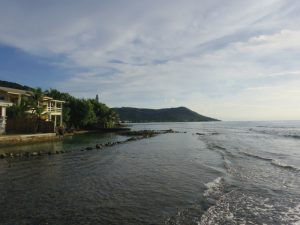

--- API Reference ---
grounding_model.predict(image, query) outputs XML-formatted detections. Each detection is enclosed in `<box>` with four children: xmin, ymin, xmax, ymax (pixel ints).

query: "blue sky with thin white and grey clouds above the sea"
<box><xmin>0</xmin><ymin>0</ymin><xmax>300</xmax><ymax>120</ymax></box>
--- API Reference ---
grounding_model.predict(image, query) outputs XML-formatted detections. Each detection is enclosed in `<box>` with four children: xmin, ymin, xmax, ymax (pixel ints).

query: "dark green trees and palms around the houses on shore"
<box><xmin>0</xmin><ymin>81</ymin><xmax>118</xmax><ymax>129</ymax></box>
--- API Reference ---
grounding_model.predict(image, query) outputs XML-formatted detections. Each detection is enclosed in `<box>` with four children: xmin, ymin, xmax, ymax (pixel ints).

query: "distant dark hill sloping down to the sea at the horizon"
<box><xmin>113</xmin><ymin>107</ymin><xmax>218</xmax><ymax>123</ymax></box>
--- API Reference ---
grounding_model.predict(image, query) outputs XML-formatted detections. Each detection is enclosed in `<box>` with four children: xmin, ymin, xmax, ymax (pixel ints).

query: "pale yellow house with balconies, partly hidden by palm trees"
<box><xmin>0</xmin><ymin>87</ymin><xmax>64</xmax><ymax>130</ymax></box>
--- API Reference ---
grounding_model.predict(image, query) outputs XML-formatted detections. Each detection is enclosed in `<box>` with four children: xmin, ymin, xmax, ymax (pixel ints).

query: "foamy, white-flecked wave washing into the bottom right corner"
<box><xmin>198</xmin><ymin>190</ymin><xmax>300</xmax><ymax>225</ymax></box>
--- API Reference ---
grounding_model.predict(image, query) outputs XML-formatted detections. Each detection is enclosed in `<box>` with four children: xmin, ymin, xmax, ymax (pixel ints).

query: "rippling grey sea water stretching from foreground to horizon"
<box><xmin>0</xmin><ymin>122</ymin><xmax>300</xmax><ymax>225</ymax></box>
